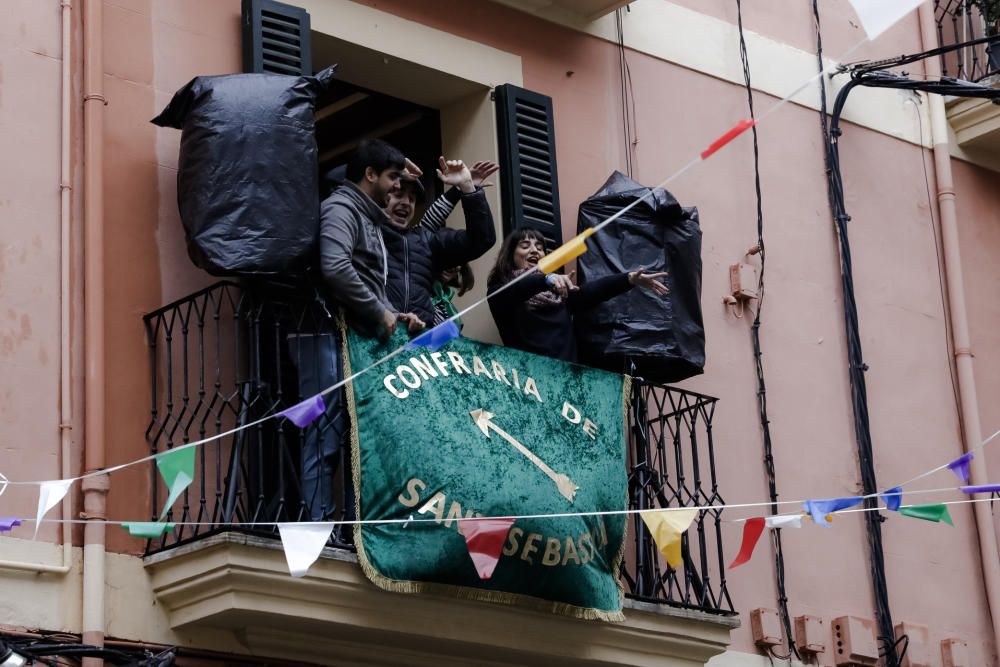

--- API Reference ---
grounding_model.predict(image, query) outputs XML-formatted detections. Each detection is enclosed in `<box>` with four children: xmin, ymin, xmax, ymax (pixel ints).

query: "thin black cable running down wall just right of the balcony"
<box><xmin>736</xmin><ymin>0</ymin><xmax>800</xmax><ymax>660</ymax></box>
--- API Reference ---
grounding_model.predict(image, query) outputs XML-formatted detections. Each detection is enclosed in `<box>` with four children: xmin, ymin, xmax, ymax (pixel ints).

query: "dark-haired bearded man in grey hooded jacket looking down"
<box><xmin>319</xmin><ymin>139</ymin><xmax>424</xmax><ymax>337</ymax></box>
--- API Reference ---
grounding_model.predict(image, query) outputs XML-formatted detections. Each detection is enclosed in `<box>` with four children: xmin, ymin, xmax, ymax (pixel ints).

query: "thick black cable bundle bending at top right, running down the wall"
<box><xmin>814</xmin><ymin>53</ymin><xmax>1000</xmax><ymax>667</ymax></box>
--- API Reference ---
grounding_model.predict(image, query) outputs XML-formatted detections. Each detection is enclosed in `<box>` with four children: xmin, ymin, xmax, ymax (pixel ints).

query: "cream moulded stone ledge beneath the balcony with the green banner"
<box><xmin>144</xmin><ymin>533</ymin><xmax>739</xmax><ymax>667</ymax></box>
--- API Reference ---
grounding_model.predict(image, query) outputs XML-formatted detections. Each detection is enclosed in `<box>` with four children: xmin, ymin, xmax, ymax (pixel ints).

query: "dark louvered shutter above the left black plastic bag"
<box><xmin>243</xmin><ymin>0</ymin><xmax>312</xmax><ymax>76</ymax></box>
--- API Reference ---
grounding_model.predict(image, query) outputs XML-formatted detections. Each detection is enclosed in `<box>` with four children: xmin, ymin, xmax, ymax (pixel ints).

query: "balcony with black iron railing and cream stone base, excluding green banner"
<box><xmin>145</xmin><ymin>282</ymin><xmax>738</xmax><ymax>665</ymax></box>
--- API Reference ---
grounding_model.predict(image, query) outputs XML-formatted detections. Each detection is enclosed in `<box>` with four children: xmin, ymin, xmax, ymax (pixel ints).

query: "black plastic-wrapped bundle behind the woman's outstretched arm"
<box><xmin>575</xmin><ymin>171</ymin><xmax>705</xmax><ymax>382</ymax></box>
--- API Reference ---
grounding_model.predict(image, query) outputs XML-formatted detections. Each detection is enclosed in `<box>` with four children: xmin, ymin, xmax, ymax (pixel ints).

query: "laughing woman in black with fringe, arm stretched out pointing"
<box><xmin>487</xmin><ymin>228</ymin><xmax>669</xmax><ymax>361</ymax></box>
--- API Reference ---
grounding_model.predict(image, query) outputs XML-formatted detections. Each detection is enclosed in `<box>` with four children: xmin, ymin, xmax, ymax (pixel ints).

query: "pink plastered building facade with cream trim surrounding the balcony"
<box><xmin>0</xmin><ymin>0</ymin><xmax>1000</xmax><ymax>667</ymax></box>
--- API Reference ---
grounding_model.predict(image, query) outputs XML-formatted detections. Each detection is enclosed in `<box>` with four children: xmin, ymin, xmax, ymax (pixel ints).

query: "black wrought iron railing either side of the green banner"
<box><xmin>144</xmin><ymin>282</ymin><xmax>735</xmax><ymax>615</ymax></box>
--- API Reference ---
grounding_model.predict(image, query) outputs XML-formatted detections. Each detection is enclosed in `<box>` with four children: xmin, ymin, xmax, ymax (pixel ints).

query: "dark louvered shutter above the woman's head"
<box><xmin>496</xmin><ymin>84</ymin><xmax>562</xmax><ymax>249</ymax></box>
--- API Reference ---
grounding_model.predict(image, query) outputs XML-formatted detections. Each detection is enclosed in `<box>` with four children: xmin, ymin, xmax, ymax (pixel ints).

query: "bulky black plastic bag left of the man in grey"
<box><xmin>152</xmin><ymin>66</ymin><xmax>335</xmax><ymax>275</ymax></box>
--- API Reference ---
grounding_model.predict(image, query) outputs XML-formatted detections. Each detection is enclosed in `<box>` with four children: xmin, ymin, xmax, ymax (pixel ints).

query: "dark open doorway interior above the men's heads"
<box><xmin>316</xmin><ymin>81</ymin><xmax>441</xmax><ymax>201</ymax></box>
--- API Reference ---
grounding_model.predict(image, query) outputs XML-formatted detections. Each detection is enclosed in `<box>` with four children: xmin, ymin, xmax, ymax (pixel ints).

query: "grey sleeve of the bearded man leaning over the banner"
<box><xmin>319</xmin><ymin>201</ymin><xmax>386</xmax><ymax>329</ymax></box>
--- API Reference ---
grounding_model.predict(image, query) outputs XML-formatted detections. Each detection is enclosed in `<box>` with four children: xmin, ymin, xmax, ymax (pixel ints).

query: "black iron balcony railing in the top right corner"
<box><xmin>928</xmin><ymin>0</ymin><xmax>1000</xmax><ymax>81</ymax></box>
